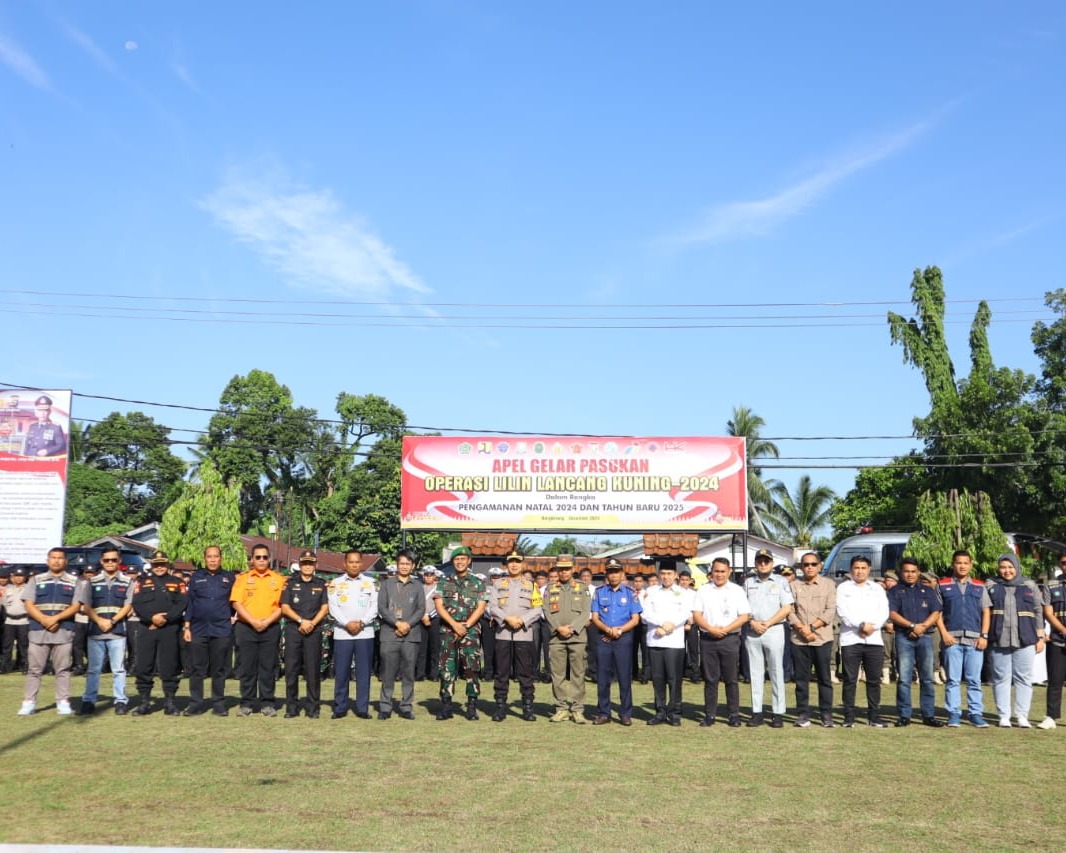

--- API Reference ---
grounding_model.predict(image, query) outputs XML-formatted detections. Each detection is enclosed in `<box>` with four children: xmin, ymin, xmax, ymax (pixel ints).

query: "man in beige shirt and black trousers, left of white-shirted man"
<box><xmin>789</xmin><ymin>551</ymin><xmax>837</xmax><ymax>728</ymax></box>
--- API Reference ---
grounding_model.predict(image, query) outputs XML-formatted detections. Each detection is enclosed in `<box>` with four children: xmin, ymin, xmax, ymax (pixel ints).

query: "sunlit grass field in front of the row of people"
<box><xmin>0</xmin><ymin>675</ymin><xmax>1066</xmax><ymax>851</ymax></box>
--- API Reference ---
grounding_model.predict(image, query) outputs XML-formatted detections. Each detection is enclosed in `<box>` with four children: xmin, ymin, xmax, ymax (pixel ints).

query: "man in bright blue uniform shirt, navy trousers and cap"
<box><xmin>592</xmin><ymin>557</ymin><xmax>643</xmax><ymax>726</ymax></box>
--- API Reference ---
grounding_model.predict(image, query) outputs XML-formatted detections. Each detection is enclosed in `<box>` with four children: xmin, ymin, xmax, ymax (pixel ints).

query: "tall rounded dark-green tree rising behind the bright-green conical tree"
<box><xmin>200</xmin><ymin>370</ymin><xmax>316</xmax><ymax>530</ymax></box>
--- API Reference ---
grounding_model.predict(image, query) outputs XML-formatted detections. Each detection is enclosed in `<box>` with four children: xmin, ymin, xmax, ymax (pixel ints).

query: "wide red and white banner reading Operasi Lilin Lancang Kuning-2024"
<box><xmin>400</xmin><ymin>435</ymin><xmax>747</xmax><ymax>531</ymax></box>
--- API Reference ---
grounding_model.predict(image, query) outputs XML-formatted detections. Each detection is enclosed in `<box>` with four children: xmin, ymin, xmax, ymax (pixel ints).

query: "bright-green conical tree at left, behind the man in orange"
<box><xmin>159</xmin><ymin>462</ymin><xmax>247</xmax><ymax>570</ymax></box>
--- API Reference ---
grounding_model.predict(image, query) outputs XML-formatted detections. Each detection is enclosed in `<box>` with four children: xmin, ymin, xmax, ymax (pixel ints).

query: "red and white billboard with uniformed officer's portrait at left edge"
<box><xmin>0</xmin><ymin>388</ymin><xmax>71</xmax><ymax>563</ymax></box>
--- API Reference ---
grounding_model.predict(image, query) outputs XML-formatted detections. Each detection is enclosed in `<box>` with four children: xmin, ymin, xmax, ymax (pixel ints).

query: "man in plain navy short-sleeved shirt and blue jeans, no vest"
<box><xmin>888</xmin><ymin>557</ymin><xmax>943</xmax><ymax>728</ymax></box>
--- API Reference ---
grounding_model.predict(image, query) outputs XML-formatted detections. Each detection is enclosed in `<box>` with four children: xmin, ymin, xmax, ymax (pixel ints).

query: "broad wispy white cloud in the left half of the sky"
<box><xmin>201</xmin><ymin>169</ymin><xmax>429</xmax><ymax>297</ymax></box>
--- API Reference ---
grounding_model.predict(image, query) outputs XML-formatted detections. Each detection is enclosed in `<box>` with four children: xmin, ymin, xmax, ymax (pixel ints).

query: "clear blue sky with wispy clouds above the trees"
<box><xmin>0</xmin><ymin>0</ymin><xmax>1066</xmax><ymax>507</ymax></box>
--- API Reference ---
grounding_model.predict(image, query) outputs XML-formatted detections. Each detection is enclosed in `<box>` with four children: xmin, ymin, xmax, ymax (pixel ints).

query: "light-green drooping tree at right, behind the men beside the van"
<box><xmin>907</xmin><ymin>489</ymin><xmax>1006</xmax><ymax>576</ymax></box>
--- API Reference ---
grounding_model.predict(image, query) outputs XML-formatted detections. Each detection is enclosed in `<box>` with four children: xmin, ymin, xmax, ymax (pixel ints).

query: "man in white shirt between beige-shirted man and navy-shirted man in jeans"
<box><xmin>837</xmin><ymin>554</ymin><xmax>888</xmax><ymax>728</ymax></box>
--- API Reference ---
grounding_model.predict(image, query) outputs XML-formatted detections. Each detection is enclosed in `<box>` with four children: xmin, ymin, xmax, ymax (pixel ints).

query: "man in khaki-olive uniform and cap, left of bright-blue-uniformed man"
<box><xmin>543</xmin><ymin>553</ymin><xmax>592</xmax><ymax>723</ymax></box>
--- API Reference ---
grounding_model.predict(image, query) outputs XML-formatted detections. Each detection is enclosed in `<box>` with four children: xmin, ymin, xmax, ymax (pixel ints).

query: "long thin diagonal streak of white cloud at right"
<box><xmin>665</xmin><ymin>115</ymin><xmax>933</xmax><ymax>246</ymax></box>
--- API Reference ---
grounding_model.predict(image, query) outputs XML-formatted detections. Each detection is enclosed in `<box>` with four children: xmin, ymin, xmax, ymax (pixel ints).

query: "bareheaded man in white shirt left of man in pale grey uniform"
<box><xmin>692</xmin><ymin>557</ymin><xmax>752</xmax><ymax>728</ymax></box>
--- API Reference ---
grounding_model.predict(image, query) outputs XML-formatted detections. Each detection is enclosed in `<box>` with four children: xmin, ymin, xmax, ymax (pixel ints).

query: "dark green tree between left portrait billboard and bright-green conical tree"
<box><xmin>79</xmin><ymin>412</ymin><xmax>185</xmax><ymax>527</ymax></box>
